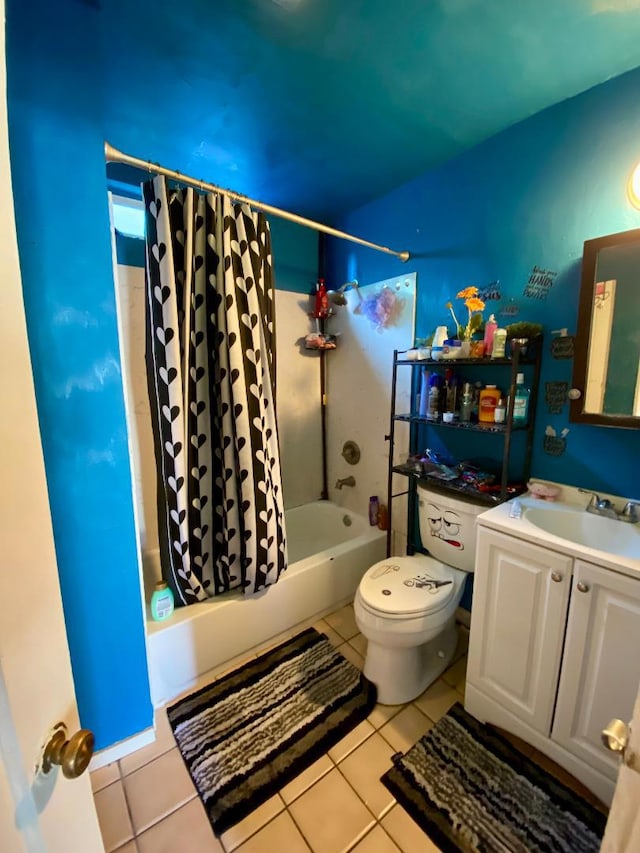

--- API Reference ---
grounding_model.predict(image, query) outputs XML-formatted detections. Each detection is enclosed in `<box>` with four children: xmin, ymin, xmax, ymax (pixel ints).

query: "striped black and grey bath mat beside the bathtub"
<box><xmin>167</xmin><ymin>628</ymin><xmax>376</xmax><ymax>834</ymax></box>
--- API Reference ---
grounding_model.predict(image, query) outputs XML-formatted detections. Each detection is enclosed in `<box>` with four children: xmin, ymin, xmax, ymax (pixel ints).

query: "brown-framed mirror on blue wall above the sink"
<box><xmin>570</xmin><ymin>228</ymin><xmax>640</xmax><ymax>428</ymax></box>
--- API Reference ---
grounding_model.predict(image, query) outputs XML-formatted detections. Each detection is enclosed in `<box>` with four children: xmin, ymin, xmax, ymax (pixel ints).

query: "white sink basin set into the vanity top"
<box><xmin>524</xmin><ymin>504</ymin><xmax>640</xmax><ymax>559</ymax></box>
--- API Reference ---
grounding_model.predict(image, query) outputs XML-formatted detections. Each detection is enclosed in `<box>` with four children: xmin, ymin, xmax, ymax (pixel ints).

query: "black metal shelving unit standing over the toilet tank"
<box><xmin>385</xmin><ymin>337</ymin><xmax>542</xmax><ymax>556</ymax></box>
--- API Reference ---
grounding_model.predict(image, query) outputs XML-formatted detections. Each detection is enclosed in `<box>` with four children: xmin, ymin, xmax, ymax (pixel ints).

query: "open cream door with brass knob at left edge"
<box><xmin>0</xmin><ymin>10</ymin><xmax>103</xmax><ymax>853</ymax></box>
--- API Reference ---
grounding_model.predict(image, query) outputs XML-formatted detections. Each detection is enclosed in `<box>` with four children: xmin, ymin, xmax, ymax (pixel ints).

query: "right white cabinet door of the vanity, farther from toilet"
<box><xmin>552</xmin><ymin>560</ymin><xmax>640</xmax><ymax>779</ymax></box>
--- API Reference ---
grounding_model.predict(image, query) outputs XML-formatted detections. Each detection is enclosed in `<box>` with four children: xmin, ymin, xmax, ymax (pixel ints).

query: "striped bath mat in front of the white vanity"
<box><xmin>382</xmin><ymin>704</ymin><xmax>606</xmax><ymax>853</ymax></box>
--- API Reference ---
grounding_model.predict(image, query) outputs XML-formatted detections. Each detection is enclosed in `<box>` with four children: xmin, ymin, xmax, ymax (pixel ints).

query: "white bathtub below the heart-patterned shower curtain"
<box><xmin>144</xmin><ymin>501</ymin><xmax>386</xmax><ymax>707</ymax></box>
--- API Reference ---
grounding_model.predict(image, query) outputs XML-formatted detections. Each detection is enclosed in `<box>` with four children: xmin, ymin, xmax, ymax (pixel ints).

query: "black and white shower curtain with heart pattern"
<box><xmin>143</xmin><ymin>177</ymin><xmax>287</xmax><ymax>604</ymax></box>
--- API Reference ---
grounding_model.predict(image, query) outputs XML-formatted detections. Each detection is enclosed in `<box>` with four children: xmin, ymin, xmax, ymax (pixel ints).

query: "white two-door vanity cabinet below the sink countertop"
<box><xmin>465</xmin><ymin>526</ymin><xmax>640</xmax><ymax>802</ymax></box>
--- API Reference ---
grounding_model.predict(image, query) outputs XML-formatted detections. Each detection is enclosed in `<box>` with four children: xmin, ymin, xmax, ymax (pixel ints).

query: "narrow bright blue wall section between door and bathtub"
<box><xmin>7</xmin><ymin>0</ymin><xmax>153</xmax><ymax>748</ymax></box>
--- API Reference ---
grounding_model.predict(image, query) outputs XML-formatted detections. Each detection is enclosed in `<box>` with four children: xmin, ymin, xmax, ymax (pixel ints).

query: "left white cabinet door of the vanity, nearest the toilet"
<box><xmin>467</xmin><ymin>527</ymin><xmax>572</xmax><ymax>735</ymax></box>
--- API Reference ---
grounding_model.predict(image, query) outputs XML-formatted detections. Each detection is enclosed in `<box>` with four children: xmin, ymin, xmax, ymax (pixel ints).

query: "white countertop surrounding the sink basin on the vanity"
<box><xmin>477</xmin><ymin>497</ymin><xmax>640</xmax><ymax>578</ymax></box>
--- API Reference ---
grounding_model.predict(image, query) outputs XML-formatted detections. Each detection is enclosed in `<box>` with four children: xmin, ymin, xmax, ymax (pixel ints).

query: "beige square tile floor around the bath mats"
<box><xmin>91</xmin><ymin>605</ymin><xmax>604</xmax><ymax>853</ymax></box>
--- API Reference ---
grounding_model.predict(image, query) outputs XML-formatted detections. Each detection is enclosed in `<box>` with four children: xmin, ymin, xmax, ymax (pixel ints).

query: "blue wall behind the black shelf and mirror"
<box><xmin>327</xmin><ymin>70</ymin><xmax>640</xmax><ymax>498</ymax></box>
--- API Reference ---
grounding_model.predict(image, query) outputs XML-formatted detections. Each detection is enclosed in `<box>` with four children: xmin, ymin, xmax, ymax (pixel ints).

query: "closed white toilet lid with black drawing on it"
<box><xmin>359</xmin><ymin>554</ymin><xmax>456</xmax><ymax>614</ymax></box>
